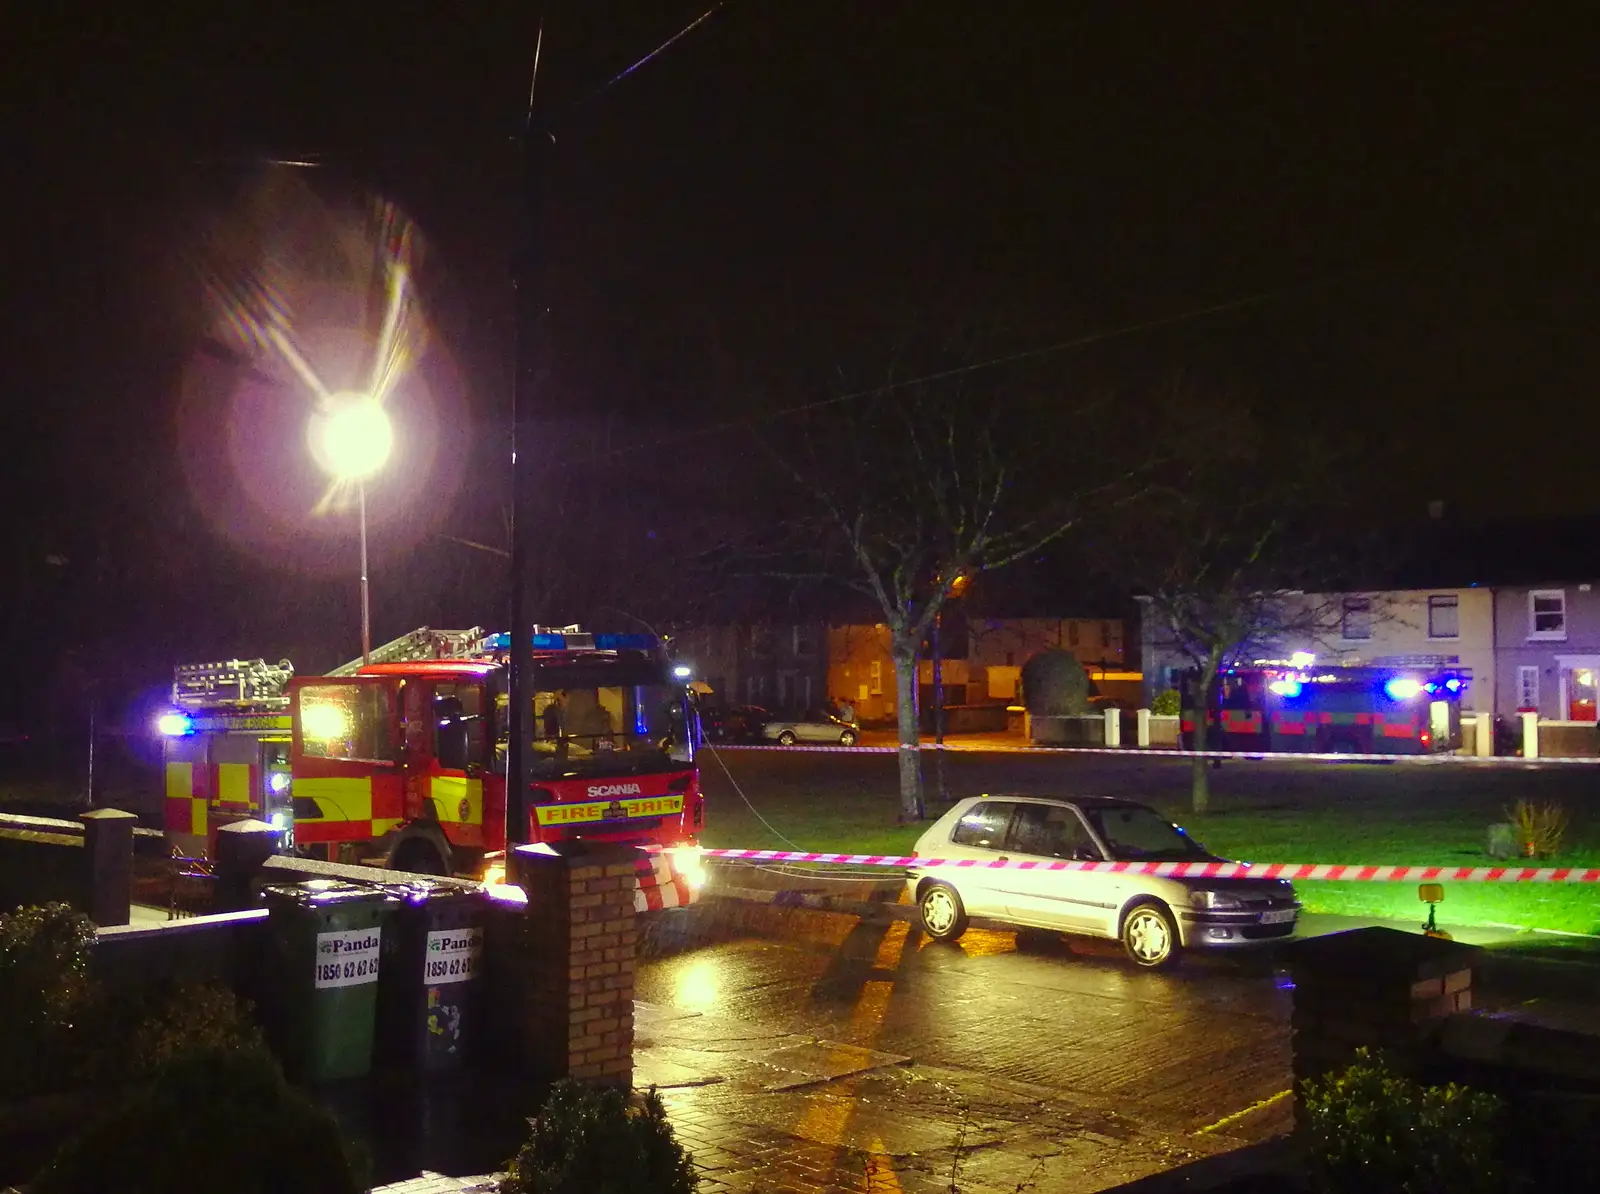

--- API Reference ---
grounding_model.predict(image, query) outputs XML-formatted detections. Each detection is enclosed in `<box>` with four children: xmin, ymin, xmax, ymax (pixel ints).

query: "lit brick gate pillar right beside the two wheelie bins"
<box><xmin>507</xmin><ymin>842</ymin><xmax>638</xmax><ymax>1087</ymax></box>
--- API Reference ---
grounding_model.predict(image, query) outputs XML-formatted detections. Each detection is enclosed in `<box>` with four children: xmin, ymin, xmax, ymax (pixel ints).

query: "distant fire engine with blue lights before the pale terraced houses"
<box><xmin>1181</xmin><ymin>656</ymin><xmax>1470</xmax><ymax>754</ymax></box>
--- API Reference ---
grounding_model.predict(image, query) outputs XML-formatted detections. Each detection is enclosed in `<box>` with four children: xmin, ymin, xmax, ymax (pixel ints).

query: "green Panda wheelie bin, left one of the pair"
<box><xmin>262</xmin><ymin>879</ymin><xmax>397</xmax><ymax>1082</ymax></box>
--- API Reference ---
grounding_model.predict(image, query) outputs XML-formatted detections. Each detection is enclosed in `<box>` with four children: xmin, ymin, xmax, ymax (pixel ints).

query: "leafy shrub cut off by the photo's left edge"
<box><xmin>0</xmin><ymin>904</ymin><xmax>94</xmax><ymax>1095</ymax></box>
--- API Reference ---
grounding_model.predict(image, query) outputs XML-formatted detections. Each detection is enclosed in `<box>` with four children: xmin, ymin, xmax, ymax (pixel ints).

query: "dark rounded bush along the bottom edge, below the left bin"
<box><xmin>29</xmin><ymin>1050</ymin><xmax>365</xmax><ymax>1194</ymax></box>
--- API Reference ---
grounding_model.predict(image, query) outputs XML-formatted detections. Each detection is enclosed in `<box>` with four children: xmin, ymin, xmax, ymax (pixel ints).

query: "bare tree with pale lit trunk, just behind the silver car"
<box><xmin>766</xmin><ymin>381</ymin><xmax>1130</xmax><ymax>821</ymax></box>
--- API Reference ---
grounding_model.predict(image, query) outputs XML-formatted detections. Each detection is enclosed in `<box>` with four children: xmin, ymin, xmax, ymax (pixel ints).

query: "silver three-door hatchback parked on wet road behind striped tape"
<box><xmin>906</xmin><ymin>795</ymin><xmax>1299</xmax><ymax>967</ymax></box>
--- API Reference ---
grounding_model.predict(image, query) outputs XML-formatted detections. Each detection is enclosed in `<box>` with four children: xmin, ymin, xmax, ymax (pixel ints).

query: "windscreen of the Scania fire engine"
<box><xmin>496</xmin><ymin>683</ymin><xmax>691</xmax><ymax>779</ymax></box>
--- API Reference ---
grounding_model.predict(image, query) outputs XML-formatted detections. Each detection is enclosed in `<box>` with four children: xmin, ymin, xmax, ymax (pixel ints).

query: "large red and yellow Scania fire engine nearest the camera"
<box><xmin>160</xmin><ymin>627</ymin><xmax>704</xmax><ymax>904</ymax></box>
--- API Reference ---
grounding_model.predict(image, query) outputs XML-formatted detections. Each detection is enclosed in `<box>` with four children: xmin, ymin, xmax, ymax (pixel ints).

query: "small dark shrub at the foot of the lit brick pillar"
<box><xmin>501</xmin><ymin>1080</ymin><xmax>699</xmax><ymax>1194</ymax></box>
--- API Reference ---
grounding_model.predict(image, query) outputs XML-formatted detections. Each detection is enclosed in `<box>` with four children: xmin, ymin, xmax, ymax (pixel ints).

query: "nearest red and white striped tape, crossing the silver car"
<box><xmin>701</xmin><ymin>848</ymin><xmax>1600</xmax><ymax>883</ymax></box>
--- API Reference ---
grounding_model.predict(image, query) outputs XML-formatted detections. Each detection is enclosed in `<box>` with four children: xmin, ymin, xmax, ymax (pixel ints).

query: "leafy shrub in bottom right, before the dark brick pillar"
<box><xmin>1301</xmin><ymin>1048</ymin><xmax>1502</xmax><ymax>1194</ymax></box>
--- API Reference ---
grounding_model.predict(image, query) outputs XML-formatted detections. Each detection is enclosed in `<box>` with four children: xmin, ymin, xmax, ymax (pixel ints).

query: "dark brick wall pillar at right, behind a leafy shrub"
<box><xmin>1291</xmin><ymin>928</ymin><xmax>1478</xmax><ymax>1117</ymax></box>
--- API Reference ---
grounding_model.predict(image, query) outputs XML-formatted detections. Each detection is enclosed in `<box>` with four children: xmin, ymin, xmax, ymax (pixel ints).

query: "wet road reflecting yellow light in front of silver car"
<box><xmin>635</xmin><ymin>909</ymin><xmax>1290</xmax><ymax>1194</ymax></box>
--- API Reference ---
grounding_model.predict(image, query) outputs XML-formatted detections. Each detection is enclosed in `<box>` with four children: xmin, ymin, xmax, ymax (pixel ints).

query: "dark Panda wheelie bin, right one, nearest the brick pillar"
<box><xmin>378</xmin><ymin>879</ymin><xmax>488</xmax><ymax>1072</ymax></box>
